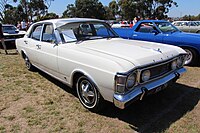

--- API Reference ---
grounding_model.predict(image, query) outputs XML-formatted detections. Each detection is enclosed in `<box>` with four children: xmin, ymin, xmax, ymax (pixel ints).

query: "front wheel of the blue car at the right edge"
<box><xmin>184</xmin><ymin>48</ymin><xmax>197</xmax><ymax>66</ymax></box>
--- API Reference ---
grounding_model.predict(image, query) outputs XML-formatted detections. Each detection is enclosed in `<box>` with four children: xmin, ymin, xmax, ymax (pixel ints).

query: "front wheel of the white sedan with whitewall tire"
<box><xmin>76</xmin><ymin>76</ymin><xmax>104</xmax><ymax>112</ymax></box>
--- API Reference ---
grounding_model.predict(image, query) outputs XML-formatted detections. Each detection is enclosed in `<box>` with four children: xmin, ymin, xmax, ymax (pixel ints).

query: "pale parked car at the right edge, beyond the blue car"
<box><xmin>172</xmin><ymin>21</ymin><xmax>200</xmax><ymax>33</ymax></box>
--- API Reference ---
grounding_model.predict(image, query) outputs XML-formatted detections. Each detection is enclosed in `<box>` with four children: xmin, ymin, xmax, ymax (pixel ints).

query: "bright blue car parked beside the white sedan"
<box><xmin>114</xmin><ymin>20</ymin><xmax>200</xmax><ymax>65</ymax></box>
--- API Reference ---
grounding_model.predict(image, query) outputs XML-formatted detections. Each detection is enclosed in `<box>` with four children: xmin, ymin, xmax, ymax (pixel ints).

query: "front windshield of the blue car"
<box><xmin>155</xmin><ymin>22</ymin><xmax>179</xmax><ymax>33</ymax></box>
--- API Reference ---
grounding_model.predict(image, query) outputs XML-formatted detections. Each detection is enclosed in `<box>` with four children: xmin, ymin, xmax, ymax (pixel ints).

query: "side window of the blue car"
<box><xmin>136</xmin><ymin>23</ymin><xmax>155</xmax><ymax>33</ymax></box>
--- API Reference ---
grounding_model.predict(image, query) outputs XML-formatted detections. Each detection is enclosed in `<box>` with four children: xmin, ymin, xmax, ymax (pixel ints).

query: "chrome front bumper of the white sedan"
<box><xmin>113</xmin><ymin>68</ymin><xmax>186</xmax><ymax>109</ymax></box>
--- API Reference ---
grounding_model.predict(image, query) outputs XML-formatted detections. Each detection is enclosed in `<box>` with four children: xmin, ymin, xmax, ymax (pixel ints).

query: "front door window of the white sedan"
<box><xmin>42</xmin><ymin>24</ymin><xmax>56</xmax><ymax>42</ymax></box>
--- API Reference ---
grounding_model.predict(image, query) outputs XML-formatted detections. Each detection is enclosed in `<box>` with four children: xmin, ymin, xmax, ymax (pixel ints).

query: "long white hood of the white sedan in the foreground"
<box><xmin>78</xmin><ymin>38</ymin><xmax>185</xmax><ymax>66</ymax></box>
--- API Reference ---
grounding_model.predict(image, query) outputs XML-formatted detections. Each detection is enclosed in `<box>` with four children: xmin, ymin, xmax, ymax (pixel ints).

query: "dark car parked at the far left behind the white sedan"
<box><xmin>2</xmin><ymin>24</ymin><xmax>26</xmax><ymax>49</ymax></box>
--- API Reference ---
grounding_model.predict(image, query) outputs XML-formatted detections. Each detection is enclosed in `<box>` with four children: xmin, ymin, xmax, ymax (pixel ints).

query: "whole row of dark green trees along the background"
<box><xmin>0</xmin><ymin>0</ymin><xmax>181</xmax><ymax>24</ymax></box>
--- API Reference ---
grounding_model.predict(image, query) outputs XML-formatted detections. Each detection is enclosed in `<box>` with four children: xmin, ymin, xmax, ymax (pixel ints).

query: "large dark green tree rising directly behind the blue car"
<box><xmin>119</xmin><ymin>0</ymin><xmax>178</xmax><ymax>19</ymax></box>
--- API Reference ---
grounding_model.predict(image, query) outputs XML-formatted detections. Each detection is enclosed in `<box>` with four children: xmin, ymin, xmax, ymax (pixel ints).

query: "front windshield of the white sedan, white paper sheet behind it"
<box><xmin>57</xmin><ymin>22</ymin><xmax>118</xmax><ymax>42</ymax></box>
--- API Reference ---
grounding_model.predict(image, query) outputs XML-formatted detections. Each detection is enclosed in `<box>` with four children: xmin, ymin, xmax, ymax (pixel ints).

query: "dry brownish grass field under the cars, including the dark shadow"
<box><xmin>0</xmin><ymin>50</ymin><xmax>200</xmax><ymax>133</ymax></box>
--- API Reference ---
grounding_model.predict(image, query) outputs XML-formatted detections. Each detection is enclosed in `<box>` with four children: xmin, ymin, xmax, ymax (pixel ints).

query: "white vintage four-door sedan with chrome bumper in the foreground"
<box><xmin>16</xmin><ymin>18</ymin><xmax>186</xmax><ymax>111</ymax></box>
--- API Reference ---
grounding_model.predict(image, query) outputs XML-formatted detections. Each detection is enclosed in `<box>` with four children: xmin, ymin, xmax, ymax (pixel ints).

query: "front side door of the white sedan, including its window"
<box><xmin>35</xmin><ymin>23</ymin><xmax>58</xmax><ymax>76</ymax></box>
